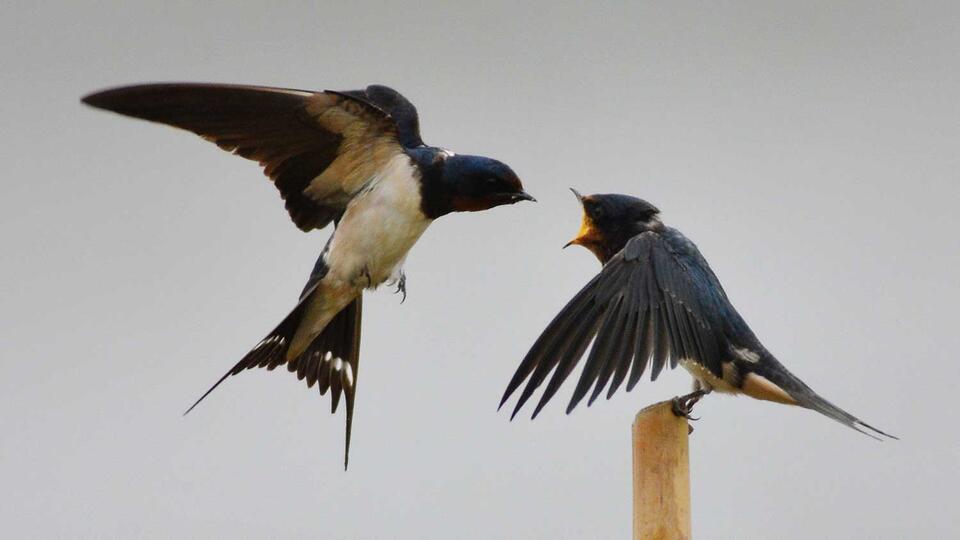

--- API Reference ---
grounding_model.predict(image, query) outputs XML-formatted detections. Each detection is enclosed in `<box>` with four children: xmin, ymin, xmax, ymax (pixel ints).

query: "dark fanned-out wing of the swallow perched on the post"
<box><xmin>500</xmin><ymin>232</ymin><xmax>727</xmax><ymax>418</ymax></box>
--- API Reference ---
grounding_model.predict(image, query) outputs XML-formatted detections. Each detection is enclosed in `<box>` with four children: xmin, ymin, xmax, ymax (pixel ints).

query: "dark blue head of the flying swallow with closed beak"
<box><xmin>441</xmin><ymin>154</ymin><xmax>536</xmax><ymax>213</ymax></box>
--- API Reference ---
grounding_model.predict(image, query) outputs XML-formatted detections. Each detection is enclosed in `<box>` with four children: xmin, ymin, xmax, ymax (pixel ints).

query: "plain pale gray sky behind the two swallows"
<box><xmin>0</xmin><ymin>1</ymin><xmax>960</xmax><ymax>539</ymax></box>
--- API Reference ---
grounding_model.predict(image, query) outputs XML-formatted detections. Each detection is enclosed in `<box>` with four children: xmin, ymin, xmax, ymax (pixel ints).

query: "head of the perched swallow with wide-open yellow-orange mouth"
<box><xmin>563</xmin><ymin>188</ymin><xmax>663</xmax><ymax>263</ymax></box>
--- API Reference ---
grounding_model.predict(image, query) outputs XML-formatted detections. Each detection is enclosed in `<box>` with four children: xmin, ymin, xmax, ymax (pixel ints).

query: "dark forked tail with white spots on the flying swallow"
<box><xmin>183</xmin><ymin>288</ymin><xmax>363</xmax><ymax>469</ymax></box>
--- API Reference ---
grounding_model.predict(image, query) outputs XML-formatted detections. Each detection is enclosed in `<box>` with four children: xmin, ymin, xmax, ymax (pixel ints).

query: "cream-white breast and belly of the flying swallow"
<box><xmin>327</xmin><ymin>156</ymin><xmax>432</xmax><ymax>287</ymax></box>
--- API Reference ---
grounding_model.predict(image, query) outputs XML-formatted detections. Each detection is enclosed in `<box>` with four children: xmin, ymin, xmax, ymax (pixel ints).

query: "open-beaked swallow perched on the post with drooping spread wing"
<box><xmin>500</xmin><ymin>190</ymin><xmax>895</xmax><ymax>438</ymax></box>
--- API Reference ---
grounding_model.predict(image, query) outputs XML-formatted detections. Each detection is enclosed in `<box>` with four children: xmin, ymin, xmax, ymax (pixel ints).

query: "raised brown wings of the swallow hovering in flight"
<box><xmin>83</xmin><ymin>83</ymin><xmax>422</xmax><ymax>231</ymax></box>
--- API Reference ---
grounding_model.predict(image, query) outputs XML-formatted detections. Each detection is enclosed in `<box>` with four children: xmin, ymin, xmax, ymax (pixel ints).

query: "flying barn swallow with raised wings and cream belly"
<box><xmin>83</xmin><ymin>83</ymin><xmax>534</xmax><ymax>468</ymax></box>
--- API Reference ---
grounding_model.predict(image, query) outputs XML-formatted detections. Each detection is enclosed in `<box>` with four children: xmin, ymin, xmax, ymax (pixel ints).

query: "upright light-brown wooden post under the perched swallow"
<box><xmin>633</xmin><ymin>401</ymin><xmax>691</xmax><ymax>540</ymax></box>
